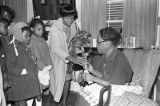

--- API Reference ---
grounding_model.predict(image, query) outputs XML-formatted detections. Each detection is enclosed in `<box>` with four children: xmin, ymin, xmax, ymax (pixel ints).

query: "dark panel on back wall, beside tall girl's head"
<box><xmin>33</xmin><ymin>0</ymin><xmax>75</xmax><ymax>20</ymax></box>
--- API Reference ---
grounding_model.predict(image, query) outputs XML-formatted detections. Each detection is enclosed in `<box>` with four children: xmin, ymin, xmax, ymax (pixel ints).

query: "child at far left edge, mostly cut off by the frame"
<box><xmin>0</xmin><ymin>18</ymin><xmax>9</xmax><ymax>106</ymax></box>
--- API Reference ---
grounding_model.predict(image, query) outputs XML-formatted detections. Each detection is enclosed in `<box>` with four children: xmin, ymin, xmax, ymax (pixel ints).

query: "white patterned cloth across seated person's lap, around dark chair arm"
<box><xmin>79</xmin><ymin>84</ymin><xmax>142</xmax><ymax>106</ymax></box>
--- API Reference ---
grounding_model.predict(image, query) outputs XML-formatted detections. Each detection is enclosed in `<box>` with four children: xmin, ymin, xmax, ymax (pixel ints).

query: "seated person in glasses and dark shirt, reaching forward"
<box><xmin>84</xmin><ymin>27</ymin><xmax>133</xmax><ymax>85</ymax></box>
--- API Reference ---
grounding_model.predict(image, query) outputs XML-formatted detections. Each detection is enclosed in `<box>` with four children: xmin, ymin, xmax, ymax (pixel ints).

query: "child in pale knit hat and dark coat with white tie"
<box><xmin>6</xmin><ymin>22</ymin><xmax>41</xmax><ymax>106</ymax></box>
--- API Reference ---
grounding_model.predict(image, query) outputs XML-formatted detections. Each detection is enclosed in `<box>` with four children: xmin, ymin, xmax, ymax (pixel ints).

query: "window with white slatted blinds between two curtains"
<box><xmin>106</xmin><ymin>0</ymin><xmax>124</xmax><ymax>31</ymax></box>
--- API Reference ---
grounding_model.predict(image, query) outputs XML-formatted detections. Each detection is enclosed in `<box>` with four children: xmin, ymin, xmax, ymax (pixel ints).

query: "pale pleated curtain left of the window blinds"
<box><xmin>81</xmin><ymin>0</ymin><xmax>106</xmax><ymax>38</ymax></box>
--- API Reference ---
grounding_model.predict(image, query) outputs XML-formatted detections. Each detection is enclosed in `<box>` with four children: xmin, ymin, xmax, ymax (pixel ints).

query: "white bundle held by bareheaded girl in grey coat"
<box><xmin>38</xmin><ymin>65</ymin><xmax>52</xmax><ymax>86</ymax></box>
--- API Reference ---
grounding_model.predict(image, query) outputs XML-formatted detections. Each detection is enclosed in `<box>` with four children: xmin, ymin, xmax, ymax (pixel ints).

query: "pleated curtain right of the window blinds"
<box><xmin>123</xmin><ymin>0</ymin><xmax>157</xmax><ymax>48</ymax></box>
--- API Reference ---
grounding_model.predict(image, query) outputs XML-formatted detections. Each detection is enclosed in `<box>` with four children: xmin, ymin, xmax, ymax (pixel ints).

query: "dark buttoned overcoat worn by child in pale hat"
<box><xmin>6</xmin><ymin>41</ymin><xmax>40</xmax><ymax>101</ymax></box>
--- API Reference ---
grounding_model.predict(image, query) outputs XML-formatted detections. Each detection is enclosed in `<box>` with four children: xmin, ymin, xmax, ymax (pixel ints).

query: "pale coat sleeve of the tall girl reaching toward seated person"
<box><xmin>49</xmin><ymin>30</ymin><xmax>69</xmax><ymax>63</ymax></box>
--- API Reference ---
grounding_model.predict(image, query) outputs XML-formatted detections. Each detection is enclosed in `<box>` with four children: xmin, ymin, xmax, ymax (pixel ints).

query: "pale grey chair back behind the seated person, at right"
<box><xmin>123</xmin><ymin>49</ymin><xmax>160</xmax><ymax>98</ymax></box>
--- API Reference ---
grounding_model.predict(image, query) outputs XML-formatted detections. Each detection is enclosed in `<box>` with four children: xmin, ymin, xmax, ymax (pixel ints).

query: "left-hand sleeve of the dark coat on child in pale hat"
<box><xmin>6</xmin><ymin>44</ymin><xmax>24</xmax><ymax>76</ymax></box>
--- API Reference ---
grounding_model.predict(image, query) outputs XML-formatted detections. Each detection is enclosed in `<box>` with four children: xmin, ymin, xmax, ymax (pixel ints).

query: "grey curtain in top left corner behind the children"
<box><xmin>5</xmin><ymin>0</ymin><xmax>27</xmax><ymax>22</ymax></box>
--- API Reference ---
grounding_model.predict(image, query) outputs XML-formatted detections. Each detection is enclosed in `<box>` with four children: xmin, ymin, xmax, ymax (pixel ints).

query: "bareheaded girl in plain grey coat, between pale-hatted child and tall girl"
<box><xmin>29</xmin><ymin>19</ymin><xmax>52</xmax><ymax>105</ymax></box>
